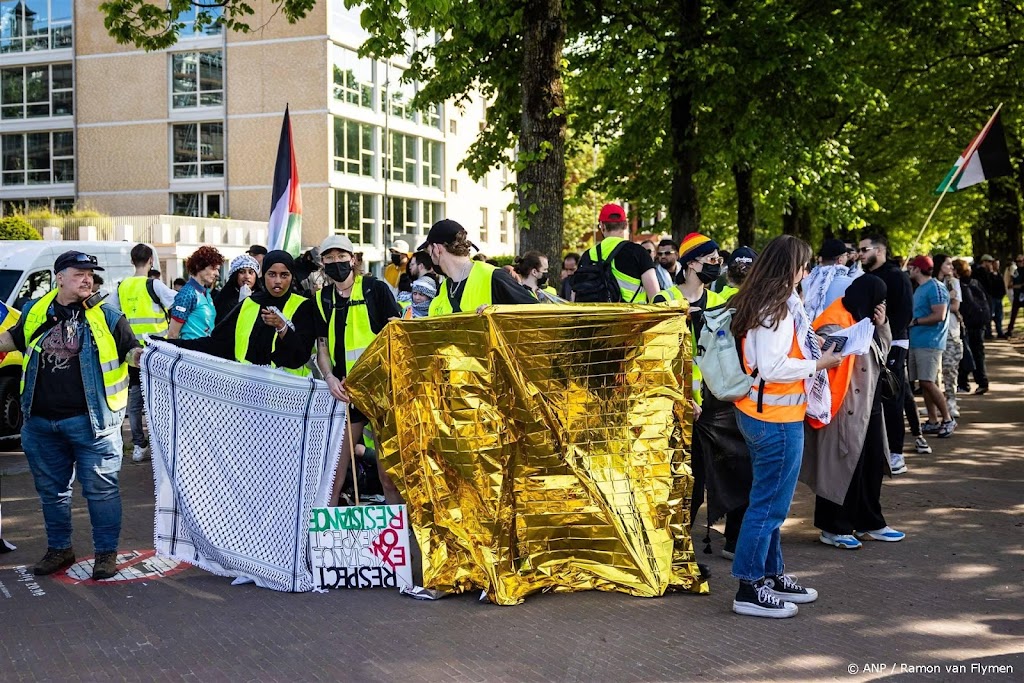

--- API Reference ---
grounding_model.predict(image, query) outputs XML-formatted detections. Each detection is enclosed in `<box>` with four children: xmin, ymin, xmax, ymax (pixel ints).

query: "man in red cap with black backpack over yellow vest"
<box><xmin>572</xmin><ymin>204</ymin><xmax>660</xmax><ymax>303</ymax></box>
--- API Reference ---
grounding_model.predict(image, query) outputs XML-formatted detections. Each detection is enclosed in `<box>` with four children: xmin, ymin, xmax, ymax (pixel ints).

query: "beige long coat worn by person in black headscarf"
<box><xmin>800</xmin><ymin>323</ymin><xmax>893</xmax><ymax>505</ymax></box>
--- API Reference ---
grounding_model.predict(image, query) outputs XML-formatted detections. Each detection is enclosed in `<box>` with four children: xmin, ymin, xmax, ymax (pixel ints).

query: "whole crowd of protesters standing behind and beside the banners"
<box><xmin>0</xmin><ymin>204</ymin><xmax>1011</xmax><ymax>617</ymax></box>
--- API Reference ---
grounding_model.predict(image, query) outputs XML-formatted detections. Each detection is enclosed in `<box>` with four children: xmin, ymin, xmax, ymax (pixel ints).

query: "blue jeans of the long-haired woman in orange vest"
<box><xmin>732</xmin><ymin>410</ymin><xmax>804</xmax><ymax>582</ymax></box>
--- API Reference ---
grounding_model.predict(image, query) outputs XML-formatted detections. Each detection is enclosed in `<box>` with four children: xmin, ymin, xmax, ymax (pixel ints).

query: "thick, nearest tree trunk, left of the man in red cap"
<box><xmin>517</xmin><ymin>0</ymin><xmax>565</xmax><ymax>263</ymax></box>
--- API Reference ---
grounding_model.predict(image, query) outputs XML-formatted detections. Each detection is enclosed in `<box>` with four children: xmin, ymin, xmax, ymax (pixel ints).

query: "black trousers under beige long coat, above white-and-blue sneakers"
<box><xmin>814</xmin><ymin>411</ymin><xmax>889</xmax><ymax>533</ymax></box>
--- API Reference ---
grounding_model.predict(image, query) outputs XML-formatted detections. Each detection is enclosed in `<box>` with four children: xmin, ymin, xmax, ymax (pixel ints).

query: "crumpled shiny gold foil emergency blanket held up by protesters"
<box><xmin>346</xmin><ymin>304</ymin><xmax>708</xmax><ymax>605</ymax></box>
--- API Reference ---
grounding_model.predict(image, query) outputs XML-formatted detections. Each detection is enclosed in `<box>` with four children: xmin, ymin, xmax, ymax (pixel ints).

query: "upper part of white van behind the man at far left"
<box><xmin>0</xmin><ymin>240</ymin><xmax>138</xmax><ymax>310</ymax></box>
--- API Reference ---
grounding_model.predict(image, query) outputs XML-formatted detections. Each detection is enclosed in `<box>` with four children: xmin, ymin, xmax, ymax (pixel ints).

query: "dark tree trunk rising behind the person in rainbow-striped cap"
<box><xmin>669</xmin><ymin>0</ymin><xmax>702</xmax><ymax>243</ymax></box>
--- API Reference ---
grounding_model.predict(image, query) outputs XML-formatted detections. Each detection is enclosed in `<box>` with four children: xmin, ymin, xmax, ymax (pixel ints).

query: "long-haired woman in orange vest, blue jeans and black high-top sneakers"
<box><xmin>730</xmin><ymin>234</ymin><xmax>842</xmax><ymax>618</ymax></box>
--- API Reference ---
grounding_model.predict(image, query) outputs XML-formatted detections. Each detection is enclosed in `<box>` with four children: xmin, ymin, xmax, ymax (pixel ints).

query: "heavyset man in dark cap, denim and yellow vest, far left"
<box><xmin>0</xmin><ymin>251</ymin><xmax>141</xmax><ymax>581</ymax></box>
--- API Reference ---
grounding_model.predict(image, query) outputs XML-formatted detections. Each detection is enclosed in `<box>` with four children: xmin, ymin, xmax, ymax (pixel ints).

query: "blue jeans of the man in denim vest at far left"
<box><xmin>22</xmin><ymin>415</ymin><xmax>122</xmax><ymax>553</ymax></box>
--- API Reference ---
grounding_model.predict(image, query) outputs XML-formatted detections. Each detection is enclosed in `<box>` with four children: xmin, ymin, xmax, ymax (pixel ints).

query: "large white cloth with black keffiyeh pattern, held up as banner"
<box><xmin>141</xmin><ymin>340</ymin><xmax>345</xmax><ymax>592</ymax></box>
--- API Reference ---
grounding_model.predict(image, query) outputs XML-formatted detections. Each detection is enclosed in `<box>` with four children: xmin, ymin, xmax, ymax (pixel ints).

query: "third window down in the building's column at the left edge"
<box><xmin>0</xmin><ymin>130</ymin><xmax>75</xmax><ymax>185</ymax></box>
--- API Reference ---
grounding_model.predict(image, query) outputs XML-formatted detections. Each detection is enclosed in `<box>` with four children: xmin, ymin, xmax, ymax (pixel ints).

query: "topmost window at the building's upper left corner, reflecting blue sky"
<box><xmin>0</xmin><ymin>0</ymin><xmax>73</xmax><ymax>53</ymax></box>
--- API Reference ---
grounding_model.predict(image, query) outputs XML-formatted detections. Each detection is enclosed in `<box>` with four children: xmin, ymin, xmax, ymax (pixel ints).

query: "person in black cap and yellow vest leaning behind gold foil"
<box><xmin>418</xmin><ymin>218</ymin><xmax>537</xmax><ymax>315</ymax></box>
